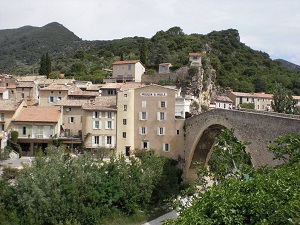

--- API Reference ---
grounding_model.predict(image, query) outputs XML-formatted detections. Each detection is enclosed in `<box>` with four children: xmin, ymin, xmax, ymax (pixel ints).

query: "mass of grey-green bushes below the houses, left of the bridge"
<box><xmin>0</xmin><ymin>146</ymin><xmax>181</xmax><ymax>224</ymax></box>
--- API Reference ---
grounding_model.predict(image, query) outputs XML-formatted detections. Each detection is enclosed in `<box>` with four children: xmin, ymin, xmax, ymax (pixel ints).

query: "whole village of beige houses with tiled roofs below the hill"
<box><xmin>0</xmin><ymin>53</ymin><xmax>300</xmax><ymax>159</ymax></box>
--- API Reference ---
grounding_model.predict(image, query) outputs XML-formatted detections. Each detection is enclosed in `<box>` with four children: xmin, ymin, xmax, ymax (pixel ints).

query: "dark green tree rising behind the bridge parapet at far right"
<box><xmin>271</xmin><ymin>83</ymin><xmax>297</xmax><ymax>114</ymax></box>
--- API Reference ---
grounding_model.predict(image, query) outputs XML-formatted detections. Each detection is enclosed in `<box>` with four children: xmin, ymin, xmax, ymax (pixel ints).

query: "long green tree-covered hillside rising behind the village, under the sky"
<box><xmin>0</xmin><ymin>23</ymin><xmax>300</xmax><ymax>95</ymax></box>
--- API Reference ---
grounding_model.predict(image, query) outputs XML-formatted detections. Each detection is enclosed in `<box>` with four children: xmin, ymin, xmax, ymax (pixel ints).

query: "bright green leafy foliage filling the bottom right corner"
<box><xmin>164</xmin><ymin>162</ymin><xmax>300</xmax><ymax>225</ymax></box>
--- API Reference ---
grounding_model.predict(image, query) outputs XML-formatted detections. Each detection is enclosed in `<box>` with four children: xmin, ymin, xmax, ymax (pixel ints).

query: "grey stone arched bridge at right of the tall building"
<box><xmin>184</xmin><ymin>109</ymin><xmax>300</xmax><ymax>182</ymax></box>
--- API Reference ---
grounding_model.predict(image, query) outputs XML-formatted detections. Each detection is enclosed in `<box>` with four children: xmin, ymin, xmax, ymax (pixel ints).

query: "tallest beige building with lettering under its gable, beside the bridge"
<box><xmin>117</xmin><ymin>84</ymin><xmax>184</xmax><ymax>159</ymax></box>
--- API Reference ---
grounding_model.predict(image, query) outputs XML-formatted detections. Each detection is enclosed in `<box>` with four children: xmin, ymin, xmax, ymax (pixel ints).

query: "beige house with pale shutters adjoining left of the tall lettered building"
<box><xmin>82</xmin><ymin>96</ymin><xmax>117</xmax><ymax>151</ymax></box>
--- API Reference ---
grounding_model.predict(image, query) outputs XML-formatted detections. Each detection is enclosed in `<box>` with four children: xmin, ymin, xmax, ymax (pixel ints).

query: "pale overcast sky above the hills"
<box><xmin>0</xmin><ymin>0</ymin><xmax>300</xmax><ymax>65</ymax></box>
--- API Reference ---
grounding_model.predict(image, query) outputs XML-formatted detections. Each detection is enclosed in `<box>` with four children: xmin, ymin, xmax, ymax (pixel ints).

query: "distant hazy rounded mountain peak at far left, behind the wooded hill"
<box><xmin>0</xmin><ymin>22</ymin><xmax>95</xmax><ymax>72</ymax></box>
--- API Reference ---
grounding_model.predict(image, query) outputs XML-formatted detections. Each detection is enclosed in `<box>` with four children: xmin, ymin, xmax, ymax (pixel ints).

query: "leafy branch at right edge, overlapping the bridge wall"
<box><xmin>268</xmin><ymin>134</ymin><xmax>300</xmax><ymax>163</ymax></box>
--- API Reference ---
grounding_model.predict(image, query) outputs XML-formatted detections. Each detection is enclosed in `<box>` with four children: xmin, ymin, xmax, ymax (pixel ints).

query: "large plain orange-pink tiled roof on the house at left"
<box><xmin>14</xmin><ymin>106</ymin><xmax>61</xmax><ymax>122</ymax></box>
